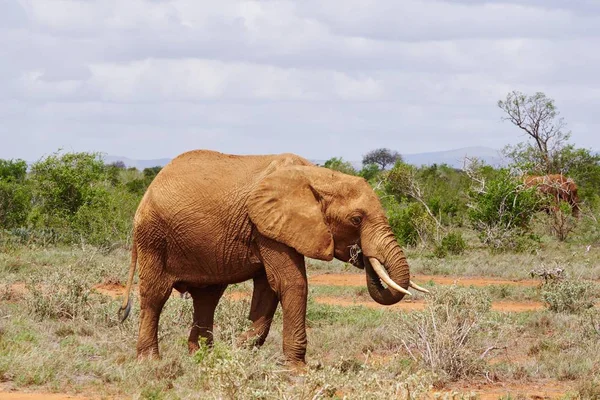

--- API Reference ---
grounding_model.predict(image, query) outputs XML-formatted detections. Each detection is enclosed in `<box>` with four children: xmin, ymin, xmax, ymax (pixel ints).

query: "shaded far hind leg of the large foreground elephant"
<box><xmin>188</xmin><ymin>285</ymin><xmax>227</xmax><ymax>354</ymax></box>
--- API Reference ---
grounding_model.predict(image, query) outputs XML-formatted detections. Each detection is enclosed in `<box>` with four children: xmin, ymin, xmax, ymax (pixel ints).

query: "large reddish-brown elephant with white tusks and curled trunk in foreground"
<box><xmin>119</xmin><ymin>150</ymin><xmax>427</xmax><ymax>365</ymax></box>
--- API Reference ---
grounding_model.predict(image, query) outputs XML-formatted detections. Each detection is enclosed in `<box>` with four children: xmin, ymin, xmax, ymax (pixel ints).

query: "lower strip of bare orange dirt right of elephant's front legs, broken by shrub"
<box><xmin>314</xmin><ymin>296</ymin><xmax>544</xmax><ymax>312</ymax></box>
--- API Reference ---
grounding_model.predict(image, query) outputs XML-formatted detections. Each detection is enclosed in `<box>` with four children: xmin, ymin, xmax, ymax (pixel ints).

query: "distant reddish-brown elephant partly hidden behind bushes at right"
<box><xmin>523</xmin><ymin>174</ymin><xmax>581</xmax><ymax>218</ymax></box>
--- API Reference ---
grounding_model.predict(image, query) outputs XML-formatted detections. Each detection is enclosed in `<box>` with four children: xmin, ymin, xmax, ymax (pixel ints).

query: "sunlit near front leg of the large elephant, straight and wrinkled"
<box><xmin>259</xmin><ymin>237</ymin><xmax>308</xmax><ymax>364</ymax></box>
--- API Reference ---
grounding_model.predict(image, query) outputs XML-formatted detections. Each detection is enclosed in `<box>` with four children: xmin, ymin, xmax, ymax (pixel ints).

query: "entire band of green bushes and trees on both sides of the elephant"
<box><xmin>0</xmin><ymin>92</ymin><xmax>600</xmax><ymax>257</ymax></box>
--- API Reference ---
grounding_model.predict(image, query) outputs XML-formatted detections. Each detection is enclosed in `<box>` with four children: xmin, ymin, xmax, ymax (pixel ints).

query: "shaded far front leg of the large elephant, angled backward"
<box><xmin>238</xmin><ymin>273</ymin><xmax>279</xmax><ymax>346</ymax></box>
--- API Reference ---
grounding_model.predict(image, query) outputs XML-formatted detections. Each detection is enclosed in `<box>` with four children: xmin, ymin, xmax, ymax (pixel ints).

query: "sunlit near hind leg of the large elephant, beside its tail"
<box><xmin>137</xmin><ymin>276</ymin><xmax>173</xmax><ymax>359</ymax></box>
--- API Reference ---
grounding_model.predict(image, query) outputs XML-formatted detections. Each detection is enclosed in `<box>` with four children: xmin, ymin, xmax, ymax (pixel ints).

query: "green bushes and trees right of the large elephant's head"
<box><xmin>324</xmin><ymin>92</ymin><xmax>600</xmax><ymax>253</ymax></box>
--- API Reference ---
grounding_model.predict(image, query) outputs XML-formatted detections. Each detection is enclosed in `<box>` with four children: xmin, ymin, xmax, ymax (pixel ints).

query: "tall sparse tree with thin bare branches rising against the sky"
<box><xmin>498</xmin><ymin>91</ymin><xmax>571</xmax><ymax>174</ymax></box>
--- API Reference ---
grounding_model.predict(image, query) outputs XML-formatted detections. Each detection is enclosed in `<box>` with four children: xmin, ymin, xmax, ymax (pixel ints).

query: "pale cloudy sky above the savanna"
<box><xmin>0</xmin><ymin>0</ymin><xmax>600</xmax><ymax>161</ymax></box>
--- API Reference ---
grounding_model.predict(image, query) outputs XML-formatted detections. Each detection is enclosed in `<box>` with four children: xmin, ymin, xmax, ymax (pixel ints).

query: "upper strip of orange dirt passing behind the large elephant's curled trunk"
<box><xmin>308</xmin><ymin>274</ymin><xmax>540</xmax><ymax>287</ymax></box>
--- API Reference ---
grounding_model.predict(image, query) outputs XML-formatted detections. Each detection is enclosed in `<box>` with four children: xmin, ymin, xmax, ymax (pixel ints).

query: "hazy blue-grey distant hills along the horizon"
<box><xmin>104</xmin><ymin>147</ymin><xmax>506</xmax><ymax>169</ymax></box>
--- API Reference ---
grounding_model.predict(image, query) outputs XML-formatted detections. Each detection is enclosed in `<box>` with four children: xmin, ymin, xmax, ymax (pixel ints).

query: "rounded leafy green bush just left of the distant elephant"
<box><xmin>468</xmin><ymin>170</ymin><xmax>540</xmax><ymax>251</ymax></box>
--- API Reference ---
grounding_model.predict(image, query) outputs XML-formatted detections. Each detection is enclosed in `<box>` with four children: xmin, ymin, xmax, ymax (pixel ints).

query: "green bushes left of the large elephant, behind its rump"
<box><xmin>0</xmin><ymin>153</ymin><xmax>160</xmax><ymax>247</ymax></box>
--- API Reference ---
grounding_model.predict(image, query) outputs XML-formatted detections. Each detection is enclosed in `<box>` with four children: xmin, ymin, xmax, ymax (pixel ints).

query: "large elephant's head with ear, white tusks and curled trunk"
<box><xmin>248</xmin><ymin>166</ymin><xmax>425</xmax><ymax>305</ymax></box>
